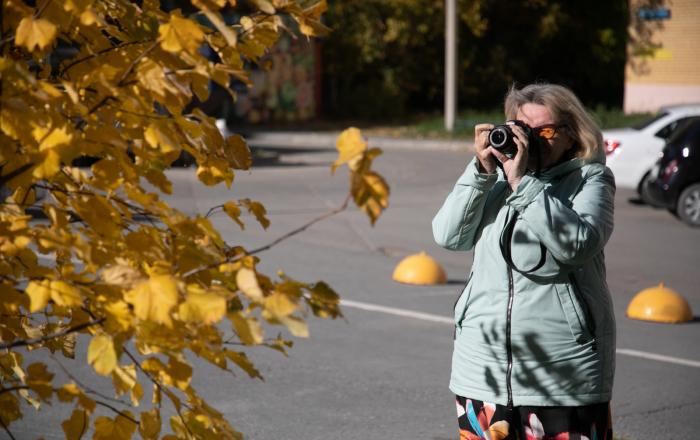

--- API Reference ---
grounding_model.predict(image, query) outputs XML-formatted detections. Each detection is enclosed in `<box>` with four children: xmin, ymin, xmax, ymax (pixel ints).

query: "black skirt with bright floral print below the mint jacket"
<box><xmin>457</xmin><ymin>396</ymin><xmax>613</xmax><ymax>440</ymax></box>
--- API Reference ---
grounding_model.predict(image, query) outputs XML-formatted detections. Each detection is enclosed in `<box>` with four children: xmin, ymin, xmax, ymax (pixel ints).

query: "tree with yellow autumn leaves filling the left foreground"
<box><xmin>0</xmin><ymin>0</ymin><xmax>389</xmax><ymax>439</ymax></box>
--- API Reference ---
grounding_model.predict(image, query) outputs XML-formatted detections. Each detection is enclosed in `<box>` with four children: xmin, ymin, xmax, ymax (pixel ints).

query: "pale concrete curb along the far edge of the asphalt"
<box><xmin>239</xmin><ymin>131</ymin><xmax>472</xmax><ymax>151</ymax></box>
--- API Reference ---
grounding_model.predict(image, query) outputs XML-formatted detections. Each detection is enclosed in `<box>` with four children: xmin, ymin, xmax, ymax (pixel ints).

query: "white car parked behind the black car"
<box><xmin>603</xmin><ymin>104</ymin><xmax>700</xmax><ymax>195</ymax></box>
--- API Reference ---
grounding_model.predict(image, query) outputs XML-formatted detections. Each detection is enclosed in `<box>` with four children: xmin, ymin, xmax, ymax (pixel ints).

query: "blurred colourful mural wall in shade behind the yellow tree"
<box><xmin>234</xmin><ymin>36</ymin><xmax>317</xmax><ymax>124</ymax></box>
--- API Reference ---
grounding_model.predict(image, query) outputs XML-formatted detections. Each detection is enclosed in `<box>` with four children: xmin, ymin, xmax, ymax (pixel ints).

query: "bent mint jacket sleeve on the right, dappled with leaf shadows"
<box><xmin>506</xmin><ymin>165</ymin><xmax>615</xmax><ymax>265</ymax></box>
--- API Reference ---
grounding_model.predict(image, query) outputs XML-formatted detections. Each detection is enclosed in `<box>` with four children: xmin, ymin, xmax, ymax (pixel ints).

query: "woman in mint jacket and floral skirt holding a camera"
<box><xmin>433</xmin><ymin>84</ymin><xmax>615</xmax><ymax>440</ymax></box>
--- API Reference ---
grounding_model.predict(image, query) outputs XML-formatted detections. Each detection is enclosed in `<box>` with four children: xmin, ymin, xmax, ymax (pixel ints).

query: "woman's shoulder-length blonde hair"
<box><xmin>505</xmin><ymin>83</ymin><xmax>605</xmax><ymax>163</ymax></box>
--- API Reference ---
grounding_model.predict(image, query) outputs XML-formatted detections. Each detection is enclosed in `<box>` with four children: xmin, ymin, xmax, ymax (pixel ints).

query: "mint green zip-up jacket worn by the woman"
<box><xmin>433</xmin><ymin>158</ymin><xmax>615</xmax><ymax>406</ymax></box>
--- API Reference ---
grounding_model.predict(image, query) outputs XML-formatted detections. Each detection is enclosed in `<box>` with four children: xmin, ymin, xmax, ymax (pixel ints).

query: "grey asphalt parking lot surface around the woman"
<box><xmin>13</xmin><ymin>143</ymin><xmax>700</xmax><ymax>440</ymax></box>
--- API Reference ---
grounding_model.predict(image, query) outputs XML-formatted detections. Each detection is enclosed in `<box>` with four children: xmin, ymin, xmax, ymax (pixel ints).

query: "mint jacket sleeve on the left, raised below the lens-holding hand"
<box><xmin>433</xmin><ymin>158</ymin><xmax>498</xmax><ymax>251</ymax></box>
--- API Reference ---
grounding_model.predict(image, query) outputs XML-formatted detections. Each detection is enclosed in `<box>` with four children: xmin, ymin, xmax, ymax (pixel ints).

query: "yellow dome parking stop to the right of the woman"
<box><xmin>627</xmin><ymin>283</ymin><xmax>693</xmax><ymax>324</ymax></box>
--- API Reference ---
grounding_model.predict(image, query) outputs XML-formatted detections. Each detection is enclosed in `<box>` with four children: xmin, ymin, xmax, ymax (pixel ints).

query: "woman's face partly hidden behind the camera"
<box><xmin>516</xmin><ymin>103</ymin><xmax>574</xmax><ymax>169</ymax></box>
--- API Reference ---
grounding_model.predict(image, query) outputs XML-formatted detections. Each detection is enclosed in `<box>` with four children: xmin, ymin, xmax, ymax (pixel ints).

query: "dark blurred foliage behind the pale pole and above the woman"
<box><xmin>322</xmin><ymin>0</ymin><xmax>628</xmax><ymax>120</ymax></box>
